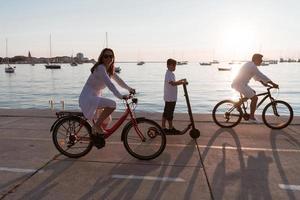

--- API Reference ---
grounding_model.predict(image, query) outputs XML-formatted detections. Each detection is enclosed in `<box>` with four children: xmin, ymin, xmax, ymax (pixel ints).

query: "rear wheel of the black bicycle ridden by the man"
<box><xmin>212</xmin><ymin>100</ymin><xmax>242</xmax><ymax>128</ymax></box>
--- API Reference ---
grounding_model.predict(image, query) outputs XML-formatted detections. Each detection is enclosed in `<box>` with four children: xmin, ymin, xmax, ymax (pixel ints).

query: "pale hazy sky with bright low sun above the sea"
<box><xmin>0</xmin><ymin>0</ymin><xmax>300</xmax><ymax>61</ymax></box>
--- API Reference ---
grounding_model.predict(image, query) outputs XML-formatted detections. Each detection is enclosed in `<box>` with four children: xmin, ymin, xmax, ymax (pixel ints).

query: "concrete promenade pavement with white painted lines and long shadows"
<box><xmin>0</xmin><ymin>109</ymin><xmax>300</xmax><ymax>200</ymax></box>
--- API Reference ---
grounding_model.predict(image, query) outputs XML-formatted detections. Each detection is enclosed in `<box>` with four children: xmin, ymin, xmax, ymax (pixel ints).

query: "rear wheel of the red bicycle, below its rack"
<box><xmin>52</xmin><ymin>116</ymin><xmax>93</xmax><ymax>158</ymax></box>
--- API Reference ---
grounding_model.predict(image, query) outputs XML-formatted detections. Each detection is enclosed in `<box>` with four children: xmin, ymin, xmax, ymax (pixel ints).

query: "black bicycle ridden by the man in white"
<box><xmin>212</xmin><ymin>85</ymin><xmax>294</xmax><ymax>129</ymax></box>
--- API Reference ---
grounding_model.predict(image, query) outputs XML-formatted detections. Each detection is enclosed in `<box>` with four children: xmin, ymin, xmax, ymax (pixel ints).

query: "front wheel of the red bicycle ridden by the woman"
<box><xmin>122</xmin><ymin>118</ymin><xmax>166</xmax><ymax>160</ymax></box>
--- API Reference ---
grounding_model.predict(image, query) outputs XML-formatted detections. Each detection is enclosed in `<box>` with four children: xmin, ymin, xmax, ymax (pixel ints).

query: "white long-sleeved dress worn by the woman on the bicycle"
<box><xmin>79</xmin><ymin>64</ymin><xmax>130</xmax><ymax>120</ymax></box>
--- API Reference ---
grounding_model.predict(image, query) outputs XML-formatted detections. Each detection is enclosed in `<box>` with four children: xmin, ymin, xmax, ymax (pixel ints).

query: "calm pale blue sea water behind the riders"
<box><xmin>0</xmin><ymin>63</ymin><xmax>300</xmax><ymax>116</ymax></box>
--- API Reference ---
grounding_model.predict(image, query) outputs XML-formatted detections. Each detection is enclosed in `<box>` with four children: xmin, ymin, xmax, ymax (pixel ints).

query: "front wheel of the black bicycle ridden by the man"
<box><xmin>262</xmin><ymin>100</ymin><xmax>294</xmax><ymax>129</ymax></box>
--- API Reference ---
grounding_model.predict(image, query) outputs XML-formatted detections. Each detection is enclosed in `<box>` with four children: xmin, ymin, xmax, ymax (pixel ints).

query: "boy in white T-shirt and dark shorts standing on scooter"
<box><xmin>162</xmin><ymin>58</ymin><xmax>186</xmax><ymax>134</ymax></box>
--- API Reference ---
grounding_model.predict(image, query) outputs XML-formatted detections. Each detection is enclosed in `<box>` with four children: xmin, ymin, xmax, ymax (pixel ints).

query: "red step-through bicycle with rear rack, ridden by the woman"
<box><xmin>50</xmin><ymin>94</ymin><xmax>166</xmax><ymax>160</ymax></box>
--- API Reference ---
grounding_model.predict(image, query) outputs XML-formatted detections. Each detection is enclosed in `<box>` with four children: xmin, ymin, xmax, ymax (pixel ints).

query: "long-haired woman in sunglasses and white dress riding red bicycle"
<box><xmin>79</xmin><ymin>48</ymin><xmax>135</xmax><ymax>138</ymax></box>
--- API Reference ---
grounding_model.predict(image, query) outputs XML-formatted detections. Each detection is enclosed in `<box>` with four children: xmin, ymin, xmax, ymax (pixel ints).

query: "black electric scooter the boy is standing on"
<box><xmin>165</xmin><ymin>82</ymin><xmax>200</xmax><ymax>139</ymax></box>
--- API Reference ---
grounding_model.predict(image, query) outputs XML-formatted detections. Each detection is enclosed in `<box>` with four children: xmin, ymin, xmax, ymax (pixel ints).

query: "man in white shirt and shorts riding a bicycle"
<box><xmin>231</xmin><ymin>54</ymin><xmax>278</xmax><ymax>122</ymax></box>
